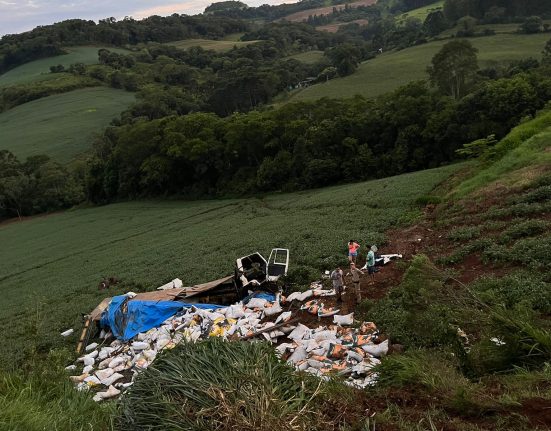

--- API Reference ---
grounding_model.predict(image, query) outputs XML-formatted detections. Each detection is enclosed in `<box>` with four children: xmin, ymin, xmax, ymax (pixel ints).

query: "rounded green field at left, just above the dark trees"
<box><xmin>0</xmin><ymin>87</ymin><xmax>134</xmax><ymax>162</ymax></box>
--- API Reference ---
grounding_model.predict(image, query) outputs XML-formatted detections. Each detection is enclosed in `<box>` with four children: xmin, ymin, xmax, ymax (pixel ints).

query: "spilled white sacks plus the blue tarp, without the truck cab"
<box><xmin>67</xmin><ymin>283</ymin><xmax>388</xmax><ymax>401</ymax></box>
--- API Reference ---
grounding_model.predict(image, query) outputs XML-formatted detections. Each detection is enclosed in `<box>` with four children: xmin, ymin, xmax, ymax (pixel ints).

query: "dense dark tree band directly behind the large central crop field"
<box><xmin>81</xmin><ymin>45</ymin><xmax>551</xmax><ymax>202</ymax></box>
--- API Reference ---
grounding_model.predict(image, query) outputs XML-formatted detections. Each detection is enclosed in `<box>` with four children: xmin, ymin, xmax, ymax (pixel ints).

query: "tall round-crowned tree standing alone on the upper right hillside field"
<box><xmin>427</xmin><ymin>40</ymin><xmax>478</xmax><ymax>99</ymax></box>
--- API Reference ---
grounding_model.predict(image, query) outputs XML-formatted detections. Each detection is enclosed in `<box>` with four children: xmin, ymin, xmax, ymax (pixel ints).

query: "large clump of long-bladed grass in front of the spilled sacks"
<box><xmin>118</xmin><ymin>339</ymin><xmax>324</xmax><ymax>431</ymax></box>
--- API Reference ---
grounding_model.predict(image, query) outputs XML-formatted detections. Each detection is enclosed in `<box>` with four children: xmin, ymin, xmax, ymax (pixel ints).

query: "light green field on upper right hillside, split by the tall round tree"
<box><xmin>287</xmin><ymin>33</ymin><xmax>549</xmax><ymax>101</ymax></box>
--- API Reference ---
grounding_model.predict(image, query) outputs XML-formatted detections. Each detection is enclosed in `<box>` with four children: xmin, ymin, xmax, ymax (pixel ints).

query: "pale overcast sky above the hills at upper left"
<box><xmin>0</xmin><ymin>0</ymin><xmax>288</xmax><ymax>36</ymax></box>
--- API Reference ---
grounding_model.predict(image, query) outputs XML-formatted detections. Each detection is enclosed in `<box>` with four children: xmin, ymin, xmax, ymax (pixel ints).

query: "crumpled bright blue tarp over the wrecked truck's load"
<box><xmin>100</xmin><ymin>295</ymin><xmax>222</xmax><ymax>341</ymax></box>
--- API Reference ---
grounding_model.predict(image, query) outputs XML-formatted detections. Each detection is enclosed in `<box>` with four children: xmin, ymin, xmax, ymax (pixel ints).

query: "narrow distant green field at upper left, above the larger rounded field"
<box><xmin>0</xmin><ymin>46</ymin><xmax>128</xmax><ymax>87</ymax></box>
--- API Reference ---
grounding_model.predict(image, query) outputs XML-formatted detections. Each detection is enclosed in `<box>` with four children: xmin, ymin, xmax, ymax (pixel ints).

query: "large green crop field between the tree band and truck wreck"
<box><xmin>0</xmin><ymin>165</ymin><xmax>461</xmax><ymax>362</ymax></box>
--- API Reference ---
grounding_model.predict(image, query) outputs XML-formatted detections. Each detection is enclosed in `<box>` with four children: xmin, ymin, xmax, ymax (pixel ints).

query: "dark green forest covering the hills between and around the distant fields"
<box><xmin>0</xmin><ymin>0</ymin><xmax>551</xmax><ymax>218</ymax></box>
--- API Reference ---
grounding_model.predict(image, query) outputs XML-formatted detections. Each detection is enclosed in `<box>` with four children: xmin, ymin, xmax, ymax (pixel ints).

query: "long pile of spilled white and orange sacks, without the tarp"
<box><xmin>67</xmin><ymin>286</ymin><xmax>388</xmax><ymax>401</ymax></box>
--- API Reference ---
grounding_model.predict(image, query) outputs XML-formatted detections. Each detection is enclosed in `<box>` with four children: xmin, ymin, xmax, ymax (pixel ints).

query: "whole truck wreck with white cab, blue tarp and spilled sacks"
<box><xmin>69</xmin><ymin>249</ymin><xmax>402</xmax><ymax>401</ymax></box>
